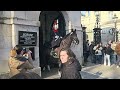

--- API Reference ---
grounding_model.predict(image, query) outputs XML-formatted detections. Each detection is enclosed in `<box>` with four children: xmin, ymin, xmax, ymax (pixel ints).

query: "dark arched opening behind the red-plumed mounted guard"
<box><xmin>39</xmin><ymin>11</ymin><xmax>66</xmax><ymax>69</ymax></box>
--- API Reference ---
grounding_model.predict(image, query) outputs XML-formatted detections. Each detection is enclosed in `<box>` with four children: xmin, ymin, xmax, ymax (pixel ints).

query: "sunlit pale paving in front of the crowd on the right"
<box><xmin>82</xmin><ymin>62</ymin><xmax>120</xmax><ymax>79</ymax></box>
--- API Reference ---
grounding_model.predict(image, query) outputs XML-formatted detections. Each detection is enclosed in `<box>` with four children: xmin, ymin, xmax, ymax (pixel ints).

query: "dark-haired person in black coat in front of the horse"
<box><xmin>59</xmin><ymin>49</ymin><xmax>82</xmax><ymax>79</ymax></box>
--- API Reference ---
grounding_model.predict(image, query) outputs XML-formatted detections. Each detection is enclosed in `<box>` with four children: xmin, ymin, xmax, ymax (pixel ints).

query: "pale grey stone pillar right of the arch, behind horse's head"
<box><xmin>68</xmin><ymin>11</ymin><xmax>83</xmax><ymax>65</ymax></box>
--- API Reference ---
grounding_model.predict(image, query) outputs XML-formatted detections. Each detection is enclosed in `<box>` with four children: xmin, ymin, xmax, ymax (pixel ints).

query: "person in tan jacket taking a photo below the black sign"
<box><xmin>8</xmin><ymin>45</ymin><xmax>34</xmax><ymax>77</ymax></box>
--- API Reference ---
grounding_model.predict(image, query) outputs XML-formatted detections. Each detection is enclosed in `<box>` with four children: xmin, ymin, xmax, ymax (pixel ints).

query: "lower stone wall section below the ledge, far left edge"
<box><xmin>0</xmin><ymin>24</ymin><xmax>12</xmax><ymax>73</ymax></box>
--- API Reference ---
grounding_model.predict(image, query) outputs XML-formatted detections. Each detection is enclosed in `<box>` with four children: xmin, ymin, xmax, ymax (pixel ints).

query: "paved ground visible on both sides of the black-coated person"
<box><xmin>42</xmin><ymin>62</ymin><xmax>120</xmax><ymax>79</ymax></box>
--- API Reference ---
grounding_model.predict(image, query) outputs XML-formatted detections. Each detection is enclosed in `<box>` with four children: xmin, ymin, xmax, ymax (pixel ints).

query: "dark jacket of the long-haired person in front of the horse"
<box><xmin>60</xmin><ymin>59</ymin><xmax>82</xmax><ymax>79</ymax></box>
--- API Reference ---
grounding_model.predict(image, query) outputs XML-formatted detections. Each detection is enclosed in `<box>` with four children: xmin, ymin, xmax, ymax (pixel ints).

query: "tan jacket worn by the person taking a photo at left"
<box><xmin>8</xmin><ymin>56</ymin><xmax>34</xmax><ymax>76</ymax></box>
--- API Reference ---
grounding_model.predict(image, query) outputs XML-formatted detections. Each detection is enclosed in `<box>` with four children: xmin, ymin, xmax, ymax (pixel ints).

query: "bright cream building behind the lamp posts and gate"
<box><xmin>81</xmin><ymin>11</ymin><xmax>120</xmax><ymax>42</ymax></box>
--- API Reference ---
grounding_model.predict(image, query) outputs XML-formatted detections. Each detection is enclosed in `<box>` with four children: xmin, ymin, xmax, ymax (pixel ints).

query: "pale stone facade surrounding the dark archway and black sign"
<box><xmin>0</xmin><ymin>11</ymin><xmax>83</xmax><ymax>76</ymax></box>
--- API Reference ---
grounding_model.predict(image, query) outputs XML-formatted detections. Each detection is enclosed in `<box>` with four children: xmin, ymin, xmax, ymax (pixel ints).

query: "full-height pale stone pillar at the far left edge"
<box><xmin>0</xmin><ymin>11</ymin><xmax>12</xmax><ymax>74</ymax></box>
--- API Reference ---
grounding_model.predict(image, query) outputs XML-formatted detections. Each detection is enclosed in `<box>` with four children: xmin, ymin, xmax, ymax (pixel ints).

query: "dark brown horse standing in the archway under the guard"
<box><xmin>42</xmin><ymin>29</ymin><xmax>79</xmax><ymax>70</ymax></box>
